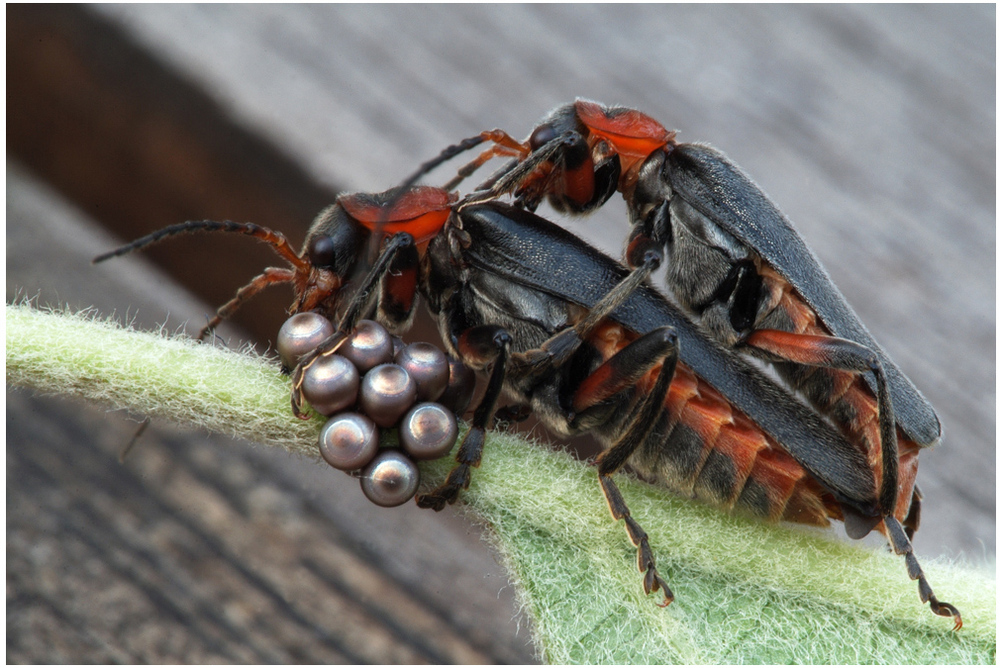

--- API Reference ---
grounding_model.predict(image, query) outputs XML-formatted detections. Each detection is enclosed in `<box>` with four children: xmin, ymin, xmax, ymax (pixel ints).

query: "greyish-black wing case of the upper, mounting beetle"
<box><xmin>664</xmin><ymin>144</ymin><xmax>941</xmax><ymax>446</ymax></box>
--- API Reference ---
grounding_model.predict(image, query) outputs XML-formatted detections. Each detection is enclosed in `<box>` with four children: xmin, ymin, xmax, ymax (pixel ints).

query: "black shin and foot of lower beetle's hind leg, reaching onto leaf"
<box><xmin>597</xmin><ymin>328</ymin><xmax>678</xmax><ymax>606</ymax></box>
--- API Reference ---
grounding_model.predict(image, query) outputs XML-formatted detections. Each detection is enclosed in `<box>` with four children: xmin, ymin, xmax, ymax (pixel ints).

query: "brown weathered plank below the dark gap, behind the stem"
<box><xmin>7</xmin><ymin>165</ymin><xmax>533</xmax><ymax>663</ymax></box>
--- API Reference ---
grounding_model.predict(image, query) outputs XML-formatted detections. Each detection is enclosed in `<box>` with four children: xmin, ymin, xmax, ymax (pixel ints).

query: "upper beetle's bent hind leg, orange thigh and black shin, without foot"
<box><xmin>743</xmin><ymin>329</ymin><xmax>899</xmax><ymax>516</ymax></box>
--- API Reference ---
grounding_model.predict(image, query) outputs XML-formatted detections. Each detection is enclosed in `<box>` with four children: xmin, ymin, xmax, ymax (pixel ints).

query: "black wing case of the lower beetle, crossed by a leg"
<box><xmin>462</xmin><ymin>203</ymin><xmax>877</xmax><ymax>515</ymax></box>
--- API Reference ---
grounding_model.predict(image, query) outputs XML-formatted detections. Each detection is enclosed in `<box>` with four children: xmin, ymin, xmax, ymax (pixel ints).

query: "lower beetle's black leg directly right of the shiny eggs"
<box><xmin>417</xmin><ymin>325</ymin><xmax>511</xmax><ymax>510</ymax></box>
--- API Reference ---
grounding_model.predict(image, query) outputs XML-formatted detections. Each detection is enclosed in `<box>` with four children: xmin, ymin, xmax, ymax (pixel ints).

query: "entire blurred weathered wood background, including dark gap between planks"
<box><xmin>6</xmin><ymin>5</ymin><xmax>996</xmax><ymax>663</ymax></box>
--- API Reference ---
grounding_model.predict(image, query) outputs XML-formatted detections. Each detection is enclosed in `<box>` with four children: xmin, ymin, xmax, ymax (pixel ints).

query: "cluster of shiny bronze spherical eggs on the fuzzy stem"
<box><xmin>278</xmin><ymin>313</ymin><xmax>476</xmax><ymax>507</ymax></box>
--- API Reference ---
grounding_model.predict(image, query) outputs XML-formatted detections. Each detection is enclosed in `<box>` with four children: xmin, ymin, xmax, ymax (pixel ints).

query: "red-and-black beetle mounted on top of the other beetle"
<box><xmin>409</xmin><ymin>100</ymin><xmax>941</xmax><ymax>538</ymax></box>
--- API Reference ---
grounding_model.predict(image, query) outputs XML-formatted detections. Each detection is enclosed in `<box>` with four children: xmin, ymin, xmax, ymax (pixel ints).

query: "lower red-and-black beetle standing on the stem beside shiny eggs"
<box><xmin>98</xmin><ymin>181</ymin><xmax>961</xmax><ymax>627</ymax></box>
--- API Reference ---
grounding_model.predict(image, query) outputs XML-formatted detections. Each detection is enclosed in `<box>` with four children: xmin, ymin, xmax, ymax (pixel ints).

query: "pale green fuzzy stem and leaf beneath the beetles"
<box><xmin>6</xmin><ymin>304</ymin><xmax>996</xmax><ymax>665</ymax></box>
